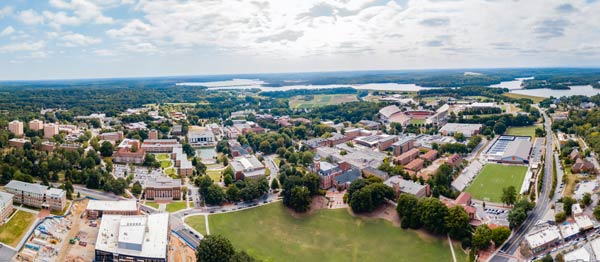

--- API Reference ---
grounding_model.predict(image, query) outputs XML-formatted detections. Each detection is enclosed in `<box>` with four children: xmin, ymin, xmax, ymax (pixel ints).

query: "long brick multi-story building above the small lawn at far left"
<box><xmin>4</xmin><ymin>180</ymin><xmax>67</xmax><ymax>210</ymax></box>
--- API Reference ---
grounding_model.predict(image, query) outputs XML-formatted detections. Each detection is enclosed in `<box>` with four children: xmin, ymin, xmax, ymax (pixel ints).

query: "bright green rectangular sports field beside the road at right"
<box><xmin>466</xmin><ymin>164</ymin><xmax>527</xmax><ymax>203</ymax></box>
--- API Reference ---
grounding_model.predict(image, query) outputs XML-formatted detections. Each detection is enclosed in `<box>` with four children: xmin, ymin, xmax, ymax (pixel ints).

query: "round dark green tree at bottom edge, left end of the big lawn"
<box><xmin>196</xmin><ymin>235</ymin><xmax>235</xmax><ymax>262</ymax></box>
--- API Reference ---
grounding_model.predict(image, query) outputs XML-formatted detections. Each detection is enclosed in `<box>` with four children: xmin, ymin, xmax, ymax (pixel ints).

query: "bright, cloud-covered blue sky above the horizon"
<box><xmin>0</xmin><ymin>0</ymin><xmax>600</xmax><ymax>80</ymax></box>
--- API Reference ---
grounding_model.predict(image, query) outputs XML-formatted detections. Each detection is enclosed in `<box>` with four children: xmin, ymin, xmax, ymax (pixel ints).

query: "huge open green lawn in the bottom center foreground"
<box><xmin>185</xmin><ymin>203</ymin><xmax>467</xmax><ymax>262</ymax></box>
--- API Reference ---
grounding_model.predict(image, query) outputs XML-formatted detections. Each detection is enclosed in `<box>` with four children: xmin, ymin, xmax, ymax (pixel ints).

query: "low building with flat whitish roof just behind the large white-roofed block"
<box><xmin>85</xmin><ymin>199</ymin><xmax>140</xmax><ymax>219</ymax></box>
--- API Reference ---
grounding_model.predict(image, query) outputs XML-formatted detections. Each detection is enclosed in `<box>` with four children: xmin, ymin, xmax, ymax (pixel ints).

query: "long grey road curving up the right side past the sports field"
<box><xmin>489</xmin><ymin>110</ymin><xmax>554</xmax><ymax>262</ymax></box>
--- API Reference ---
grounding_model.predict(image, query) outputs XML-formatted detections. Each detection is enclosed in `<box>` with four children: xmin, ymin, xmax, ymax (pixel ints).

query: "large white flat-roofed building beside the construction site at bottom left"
<box><xmin>94</xmin><ymin>213</ymin><xmax>169</xmax><ymax>262</ymax></box>
